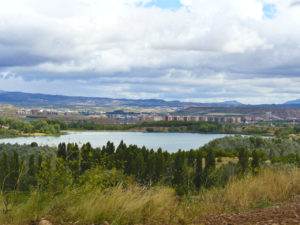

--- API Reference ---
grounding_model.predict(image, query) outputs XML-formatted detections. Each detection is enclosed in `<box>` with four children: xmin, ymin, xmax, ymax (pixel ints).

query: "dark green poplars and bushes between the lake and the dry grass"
<box><xmin>0</xmin><ymin>142</ymin><xmax>300</xmax><ymax>195</ymax></box>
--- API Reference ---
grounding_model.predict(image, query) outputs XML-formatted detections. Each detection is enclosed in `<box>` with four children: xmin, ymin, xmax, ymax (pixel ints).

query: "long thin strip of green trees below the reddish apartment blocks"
<box><xmin>66</xmin><ymin>121</ymin><xmax>300</xmax><ymax>135</ymax></box>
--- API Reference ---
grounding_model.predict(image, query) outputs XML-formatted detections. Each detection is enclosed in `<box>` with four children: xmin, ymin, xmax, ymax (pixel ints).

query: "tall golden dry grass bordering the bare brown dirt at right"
<box><xmin>182</xmin><ymin>168</ymin><xmax>300</xmax><ymax>219</ymax></box>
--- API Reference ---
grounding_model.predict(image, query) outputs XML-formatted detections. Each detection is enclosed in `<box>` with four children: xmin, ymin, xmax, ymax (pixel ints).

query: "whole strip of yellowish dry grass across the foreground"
<box><xmin>0</xmin><ymin>168</ymin><xmax>300</xmax><ymax>224</ymax></box>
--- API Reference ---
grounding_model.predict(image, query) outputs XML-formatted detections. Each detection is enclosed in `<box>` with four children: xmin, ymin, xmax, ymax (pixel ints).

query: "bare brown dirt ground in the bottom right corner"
<box><xmin>195</xmin><ymin>196</ymin><xmax>300</xmax><ymax>225</ymax></box>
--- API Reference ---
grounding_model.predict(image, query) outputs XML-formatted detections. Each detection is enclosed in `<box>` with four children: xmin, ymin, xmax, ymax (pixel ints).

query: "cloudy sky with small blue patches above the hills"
<box><xmin>0</xmin><ymin>0</ymin><xmax>300</xmax><ymax>104</ymax></box>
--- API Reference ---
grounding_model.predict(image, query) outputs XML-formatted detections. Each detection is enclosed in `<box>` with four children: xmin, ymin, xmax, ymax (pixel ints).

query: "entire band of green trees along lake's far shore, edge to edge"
<box><xmin>0</xmin><ymin>117</ymin><xmax>300</xmax><ymax>138</ymax></box>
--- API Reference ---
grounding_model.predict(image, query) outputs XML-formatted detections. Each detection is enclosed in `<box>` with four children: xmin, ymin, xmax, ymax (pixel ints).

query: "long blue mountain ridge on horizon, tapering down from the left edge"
<box><xmin>0</xmin><ymin>91</ymin><xmax>243</xmax><ymax>108</ymax></box>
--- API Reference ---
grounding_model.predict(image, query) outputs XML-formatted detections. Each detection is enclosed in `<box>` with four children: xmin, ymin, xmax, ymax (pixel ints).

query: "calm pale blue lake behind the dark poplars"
<box><xmin>0</xmin><ymin>132</ymin><xmax>231</xmax><ymax>152</ymax></box>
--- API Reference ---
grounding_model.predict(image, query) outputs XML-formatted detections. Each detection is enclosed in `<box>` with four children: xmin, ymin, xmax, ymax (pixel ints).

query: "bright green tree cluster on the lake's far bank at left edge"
<box><xmin>0</xmin><ymin>117</ymin><xmax>68</xmax><ymax>137</ymax></box>
